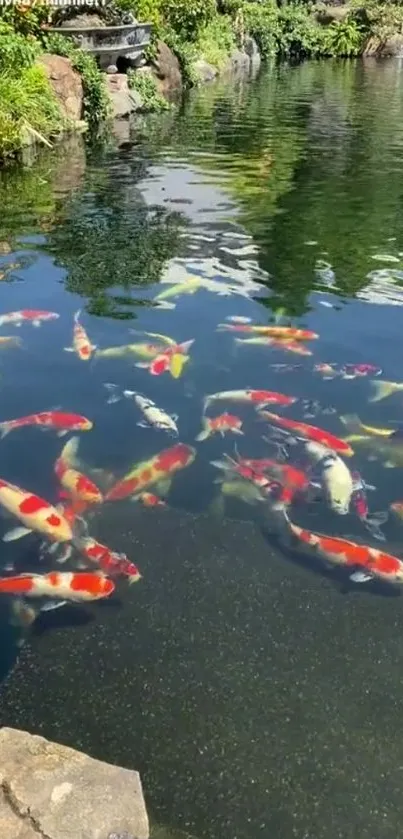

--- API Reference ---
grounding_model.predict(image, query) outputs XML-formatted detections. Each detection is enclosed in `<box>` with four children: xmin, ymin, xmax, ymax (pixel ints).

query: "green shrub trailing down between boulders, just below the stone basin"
<box><xmin>43</xmin><ymin>35</ymin><xmax>110</xmax><ymax>129</ymax></box>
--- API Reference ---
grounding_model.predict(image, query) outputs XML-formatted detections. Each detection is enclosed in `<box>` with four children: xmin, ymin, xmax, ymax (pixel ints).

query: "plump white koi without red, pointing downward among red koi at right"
<box><xmin>305</xmin><ymin>441</ymin><xmax>353</xmax><ymax>516</ymax></box>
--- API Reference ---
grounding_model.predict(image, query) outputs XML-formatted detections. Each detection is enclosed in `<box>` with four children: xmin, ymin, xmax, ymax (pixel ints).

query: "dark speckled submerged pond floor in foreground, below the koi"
<box><xmin>0</xmin><ymin>505</ymin><xmax>403</xmax><ymax>839</ymax></box>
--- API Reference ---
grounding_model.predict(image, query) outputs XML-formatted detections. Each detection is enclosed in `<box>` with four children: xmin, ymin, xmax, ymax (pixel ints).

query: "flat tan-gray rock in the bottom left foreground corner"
<box><xmin>0</xmin><ymin>728</ymin><xmax>150</xmax><ymax>839</ymax></box>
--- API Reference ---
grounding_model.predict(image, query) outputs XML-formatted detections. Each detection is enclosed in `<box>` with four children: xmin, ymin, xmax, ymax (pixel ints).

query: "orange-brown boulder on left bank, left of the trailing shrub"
<box><xmin>38</xmin><ymin>54</ymin><xmax>83</xmax><ymax>122</ymax></box>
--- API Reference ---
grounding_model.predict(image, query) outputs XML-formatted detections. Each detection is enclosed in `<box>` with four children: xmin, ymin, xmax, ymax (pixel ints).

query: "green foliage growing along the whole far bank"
<box><xmin>0</xmin><ymin>0</ymin><xmax>403</xmax><ymax>159</ymax></box>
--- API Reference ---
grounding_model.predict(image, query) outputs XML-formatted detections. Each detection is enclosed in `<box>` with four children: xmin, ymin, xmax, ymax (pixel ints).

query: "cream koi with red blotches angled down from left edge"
<box><xmin>0</xmin><ymin>479</ymin><xmax>73</xmax><ymax>542</ymax></box>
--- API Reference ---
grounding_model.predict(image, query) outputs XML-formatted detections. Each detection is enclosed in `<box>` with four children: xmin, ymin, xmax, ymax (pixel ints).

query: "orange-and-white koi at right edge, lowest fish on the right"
<box><xmin>285</xmin><ymin>514</ymin><xmax>403</xmax><ymax>585</ymax></box>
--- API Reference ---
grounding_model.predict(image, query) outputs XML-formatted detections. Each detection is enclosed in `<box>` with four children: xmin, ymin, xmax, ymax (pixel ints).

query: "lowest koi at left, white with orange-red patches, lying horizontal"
<box><xmin>0</xmin><ymin>571</ymin><xmax>115</xmax><ymax>603</ymax></box>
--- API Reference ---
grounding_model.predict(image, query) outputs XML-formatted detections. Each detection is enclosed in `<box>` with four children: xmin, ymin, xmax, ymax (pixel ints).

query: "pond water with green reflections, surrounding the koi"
<box><xmin>0</xmin><ymin>60</ymin><xmax>403</xmax><ymax>839</ymax></box>
